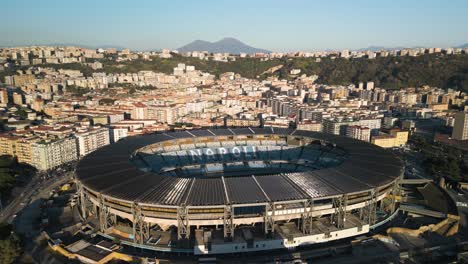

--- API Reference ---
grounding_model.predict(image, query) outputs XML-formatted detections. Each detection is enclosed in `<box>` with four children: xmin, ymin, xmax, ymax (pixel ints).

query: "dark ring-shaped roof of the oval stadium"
<box><xmin>76</xmin><ymin>128</ymin><xmax>403</xmax><ymax>206</ymax></box>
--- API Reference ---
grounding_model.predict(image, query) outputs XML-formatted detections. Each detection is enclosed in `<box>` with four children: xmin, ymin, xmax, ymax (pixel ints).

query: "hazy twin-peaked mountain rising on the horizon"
<box><xmin>177</xmin><ymin>38</ymin><xmax>270</xmax><ymax>54</ymax></box>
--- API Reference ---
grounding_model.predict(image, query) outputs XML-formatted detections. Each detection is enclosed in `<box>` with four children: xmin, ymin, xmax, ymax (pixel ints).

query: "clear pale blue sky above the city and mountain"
<box><xmin>0</xmin><ymin>0</ymin><xmax>468</xmax><ymax>51</ymax></box>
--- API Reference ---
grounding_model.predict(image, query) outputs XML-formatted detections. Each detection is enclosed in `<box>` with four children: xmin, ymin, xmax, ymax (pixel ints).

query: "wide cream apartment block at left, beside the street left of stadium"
<box><xmin>31</xmin><ymin>137</ymin><xmax>78</xmax><ymax>170</ymax></box>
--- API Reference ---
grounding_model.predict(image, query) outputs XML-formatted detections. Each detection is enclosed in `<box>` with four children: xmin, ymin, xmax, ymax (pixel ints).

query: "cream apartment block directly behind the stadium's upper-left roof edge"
<box><xmin>75</xmin><ymin>128</ymin><xmax>110</xmax><ymax>157</ymax></box>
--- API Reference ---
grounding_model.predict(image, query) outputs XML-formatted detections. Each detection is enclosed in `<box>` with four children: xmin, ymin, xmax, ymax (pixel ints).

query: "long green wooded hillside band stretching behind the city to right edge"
<box><xmin>97</xmin><ymin>54</ymin><xmax>468</xmax><ymax>91</ymax></box>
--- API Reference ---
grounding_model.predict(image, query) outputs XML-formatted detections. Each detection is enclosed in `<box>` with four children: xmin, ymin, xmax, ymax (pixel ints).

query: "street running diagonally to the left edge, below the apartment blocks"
<box><xmin>0</xmin><ymin>172</ymin><xmax>73</xmax><ymax>223</ymax></box>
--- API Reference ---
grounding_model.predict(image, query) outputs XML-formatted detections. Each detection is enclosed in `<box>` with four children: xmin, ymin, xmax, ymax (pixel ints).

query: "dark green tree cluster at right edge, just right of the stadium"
<box><xmin>410</xmin><ymin>136</ymin><xmax>468</xmax><ymax>182</ymax></box>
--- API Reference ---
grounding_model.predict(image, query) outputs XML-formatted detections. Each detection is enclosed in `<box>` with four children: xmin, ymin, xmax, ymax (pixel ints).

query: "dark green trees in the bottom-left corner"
<box><xmin>0</xmin><ymin>223</ymin><xmax>22</xmax><ymax>264</ymax></box>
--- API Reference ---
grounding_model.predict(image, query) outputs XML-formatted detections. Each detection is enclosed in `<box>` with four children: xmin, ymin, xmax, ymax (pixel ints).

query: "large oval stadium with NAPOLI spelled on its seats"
<box><xmin>75</xmin><ymin>128</ymin><xmax>404</xmax><ymax>254</ymax></box>
